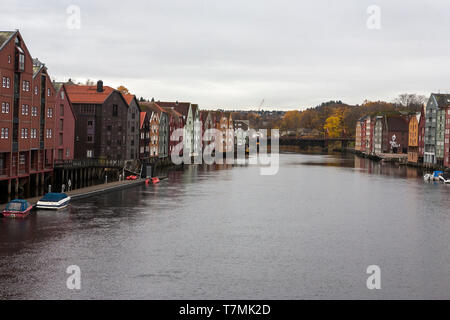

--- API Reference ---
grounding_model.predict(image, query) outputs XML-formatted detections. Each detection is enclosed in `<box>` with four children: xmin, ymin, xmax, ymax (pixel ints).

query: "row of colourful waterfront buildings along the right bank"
<box><xmin>355</xmin><ymin>93</ymin><xmax>450</xmax><ymax>167</ymax></box>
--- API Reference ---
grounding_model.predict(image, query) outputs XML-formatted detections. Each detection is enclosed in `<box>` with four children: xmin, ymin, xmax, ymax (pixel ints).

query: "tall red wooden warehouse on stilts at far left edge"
<box><xmin>0</xmin><ymin>31</ymin><xmax>55</xmax><ymax>202</ymax></box>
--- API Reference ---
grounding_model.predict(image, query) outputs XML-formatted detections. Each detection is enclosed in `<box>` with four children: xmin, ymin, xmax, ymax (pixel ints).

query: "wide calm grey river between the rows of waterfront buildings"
<box><xmin>0</xmin><ymin>154</ymin><xmax>450</xmax><ymax>299</ymax></box>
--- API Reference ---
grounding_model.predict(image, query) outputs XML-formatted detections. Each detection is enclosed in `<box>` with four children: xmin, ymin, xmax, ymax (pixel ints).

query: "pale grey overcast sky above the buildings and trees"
<box><xmin>0</xmin><ymin>0</ymin><xmax>450</xmax><ymax>110</ymax></box>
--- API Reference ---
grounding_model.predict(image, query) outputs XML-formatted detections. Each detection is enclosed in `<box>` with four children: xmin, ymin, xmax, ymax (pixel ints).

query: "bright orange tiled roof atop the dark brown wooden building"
<box><xmin>65</xmin><ymin>84</ymin><xmax>118</xmax><ymax>104</ymax></box>
